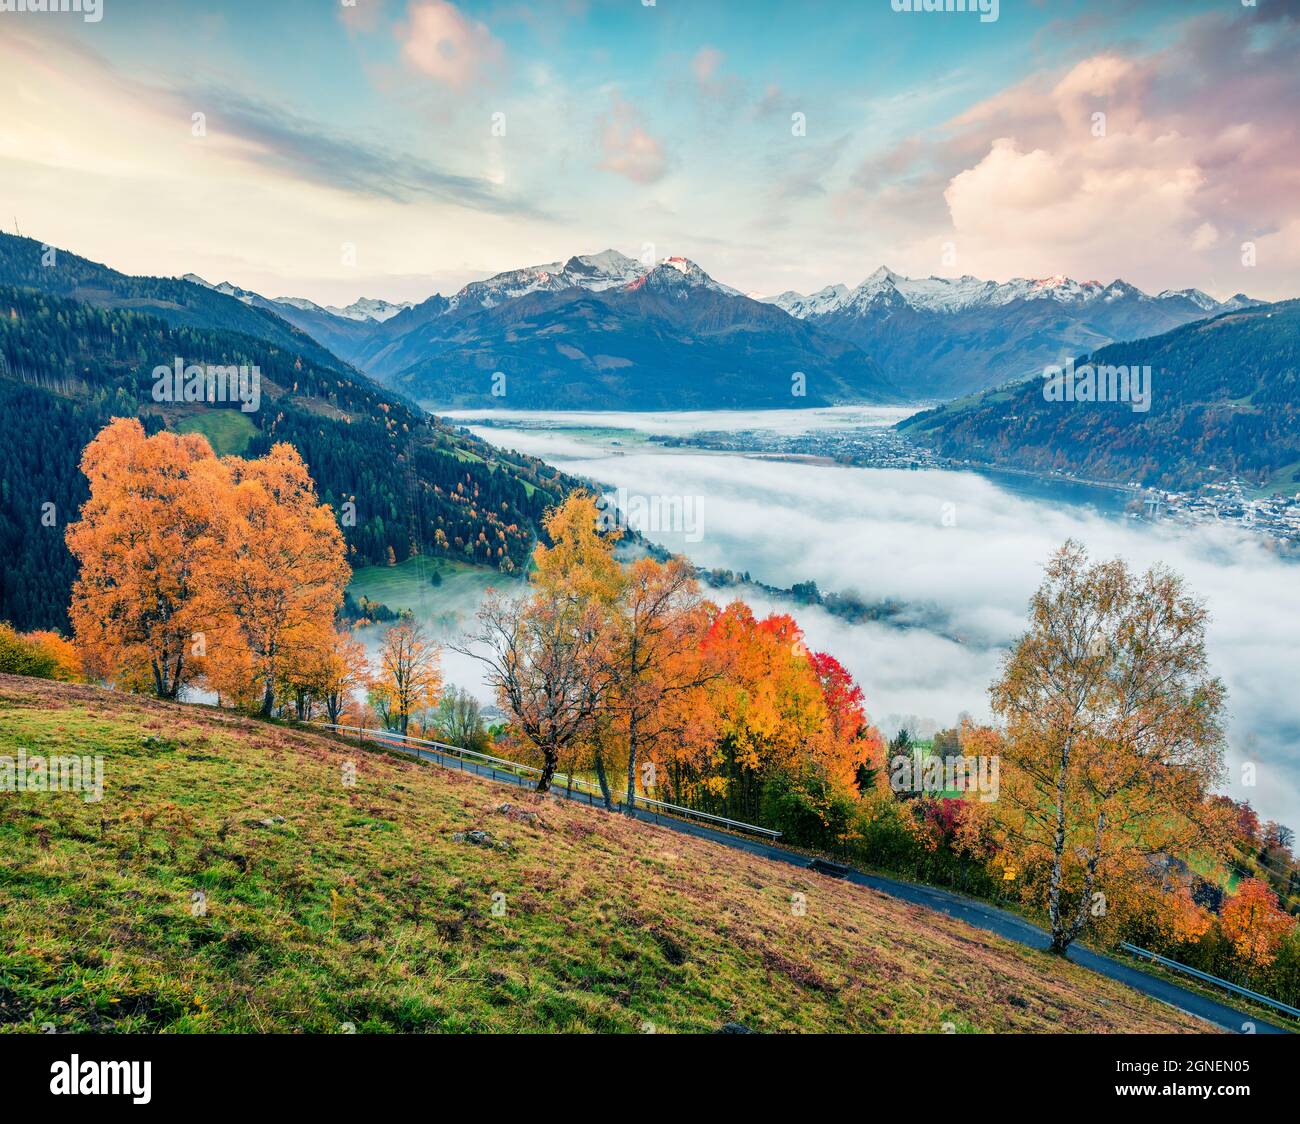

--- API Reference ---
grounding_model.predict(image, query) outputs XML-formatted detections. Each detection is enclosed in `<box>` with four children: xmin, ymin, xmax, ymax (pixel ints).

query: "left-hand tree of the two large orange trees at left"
<box><xmin>66</xmin><ymin>418</ymin><xmax>230</xmax><ymax>699</ymax></box>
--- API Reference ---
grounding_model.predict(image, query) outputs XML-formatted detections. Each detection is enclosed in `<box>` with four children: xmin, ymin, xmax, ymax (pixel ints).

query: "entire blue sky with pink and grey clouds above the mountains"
<box><xmin>0</xmin><ymin>0</ymin><xmax>1300</xmax><ymax>304</ymax></box>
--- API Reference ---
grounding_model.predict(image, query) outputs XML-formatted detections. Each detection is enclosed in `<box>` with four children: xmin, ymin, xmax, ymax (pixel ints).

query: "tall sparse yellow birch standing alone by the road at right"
<box><xmin>985</xmin><ymin>542</ymin><xmax>1225</xmax><ymax>954</ymax></box>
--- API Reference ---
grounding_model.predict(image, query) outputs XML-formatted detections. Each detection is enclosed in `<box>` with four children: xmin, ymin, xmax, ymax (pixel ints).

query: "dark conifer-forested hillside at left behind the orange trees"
<box><xmin>0</xmin><ymin>280</ymin><xmax>568</xmax><ymax>629</ymax></box>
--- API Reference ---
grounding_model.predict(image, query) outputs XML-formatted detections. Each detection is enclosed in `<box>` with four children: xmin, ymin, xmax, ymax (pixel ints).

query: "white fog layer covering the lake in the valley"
<box><xmin>445</xmin><ymin>408</ymin><xmax>1300</xmax><ymax>825</ymax></box>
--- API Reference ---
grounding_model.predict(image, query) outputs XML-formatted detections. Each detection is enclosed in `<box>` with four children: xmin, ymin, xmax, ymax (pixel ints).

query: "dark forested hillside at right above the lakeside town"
<box><xmin>900</xmin><ymin>300</ymin><xmax>1300</xmax><ymax>491</ymax></box>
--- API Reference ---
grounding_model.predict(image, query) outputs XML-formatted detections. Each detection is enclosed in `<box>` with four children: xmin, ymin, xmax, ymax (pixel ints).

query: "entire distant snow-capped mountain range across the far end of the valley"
<box><xmin>186</xmin><ymin>249</ymin><xmax>1256</xmax><ymax>409</ymax></box>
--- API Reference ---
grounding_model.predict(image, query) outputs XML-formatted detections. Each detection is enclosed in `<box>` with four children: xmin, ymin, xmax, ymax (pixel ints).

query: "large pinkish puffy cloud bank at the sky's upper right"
<box><xmin>849</xmin><ymin>4</ymin><xmax>1300</xmax><ymax>298</ymax></box>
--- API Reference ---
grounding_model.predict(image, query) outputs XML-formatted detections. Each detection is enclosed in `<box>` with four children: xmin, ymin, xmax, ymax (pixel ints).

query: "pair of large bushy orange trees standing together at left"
<box><xmin>68</xmin><ymin>418</ymin><xmax>350</xmax><ymax>715</ymax></box>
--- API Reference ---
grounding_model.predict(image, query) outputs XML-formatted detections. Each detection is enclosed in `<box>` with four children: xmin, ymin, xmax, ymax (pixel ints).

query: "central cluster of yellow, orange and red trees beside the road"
<box><xmin>465</xmin><ymin>494</ymin><xmax>883</xmax><ymax>821</ymax></box>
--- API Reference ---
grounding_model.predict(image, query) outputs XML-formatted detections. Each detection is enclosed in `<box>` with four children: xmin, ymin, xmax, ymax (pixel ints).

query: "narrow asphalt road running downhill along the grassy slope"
<box><xmin>366</xmin><ymin>743</ymin><xmax>1290</xmax><ymax>1034</ymax></box>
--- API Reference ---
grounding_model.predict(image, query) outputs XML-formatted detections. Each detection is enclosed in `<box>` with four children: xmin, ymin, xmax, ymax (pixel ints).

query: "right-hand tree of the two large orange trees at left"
<box><xmin>200</xmin><ymin>443</ymin><xmax>351</xmax><ymax>715</ymax></box>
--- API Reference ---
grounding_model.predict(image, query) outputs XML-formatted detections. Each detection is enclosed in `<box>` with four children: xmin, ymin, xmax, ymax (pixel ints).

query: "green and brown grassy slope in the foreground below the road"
<box><xmin>0</xmin><ymin>676</ymin><xmax>1208</xmax><ymax>1033</ymax></box>
